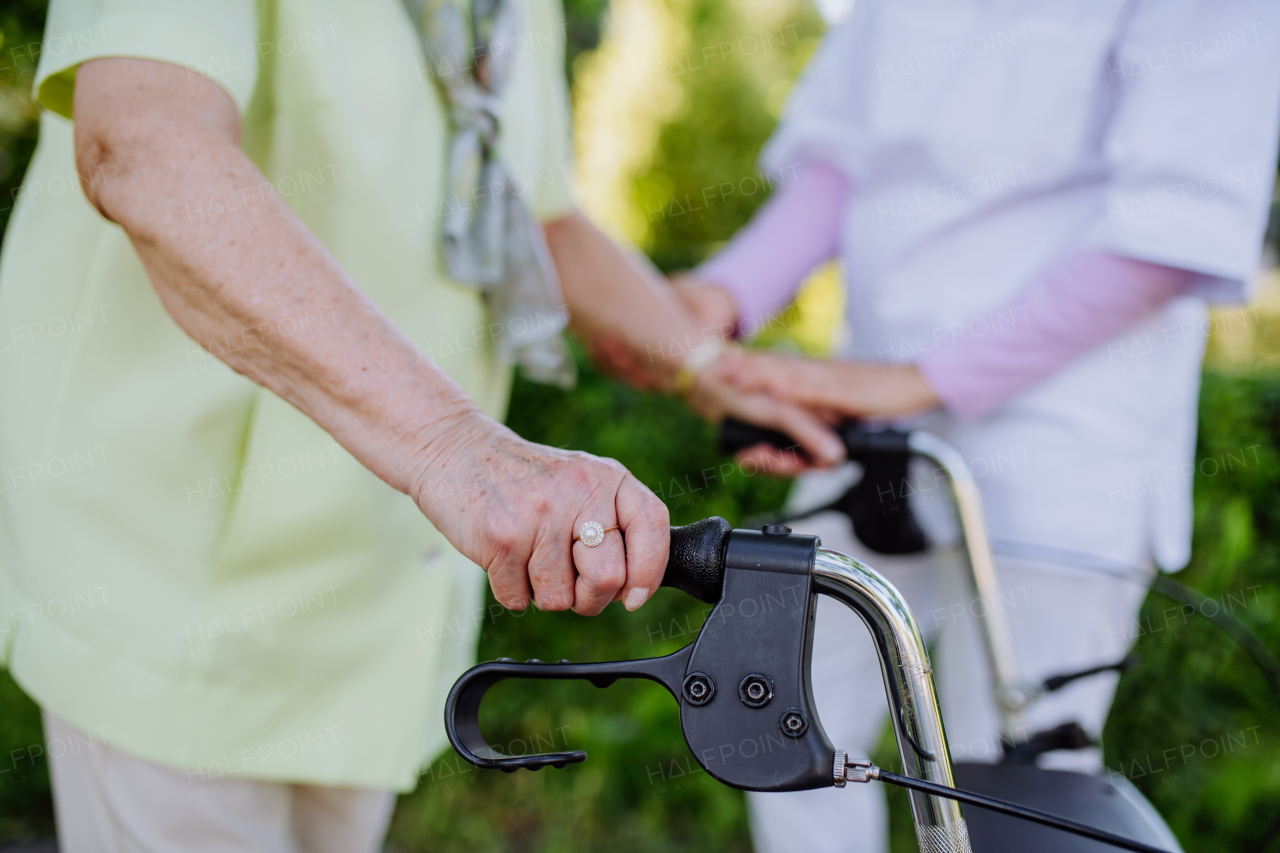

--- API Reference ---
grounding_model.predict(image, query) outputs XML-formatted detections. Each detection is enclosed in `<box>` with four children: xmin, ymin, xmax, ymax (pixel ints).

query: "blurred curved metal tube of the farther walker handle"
<box><xmin>908</xmin><ymin>430</ymin><xmax>1030</xmax><ymax>743</ymax></box>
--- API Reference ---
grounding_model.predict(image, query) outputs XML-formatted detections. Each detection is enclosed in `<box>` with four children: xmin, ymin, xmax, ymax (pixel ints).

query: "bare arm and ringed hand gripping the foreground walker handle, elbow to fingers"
<box><xmin>74</xmin><ymin>58</ymin><xmax>669</xmax><ymax>613</ymax></box>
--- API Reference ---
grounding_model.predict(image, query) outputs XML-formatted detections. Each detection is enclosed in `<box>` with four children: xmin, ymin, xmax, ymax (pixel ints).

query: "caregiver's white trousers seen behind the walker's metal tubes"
<box><xmin>748</xmin><ymin>504</ymin><xmax>1146</xmax><ymax>853</ymax></box>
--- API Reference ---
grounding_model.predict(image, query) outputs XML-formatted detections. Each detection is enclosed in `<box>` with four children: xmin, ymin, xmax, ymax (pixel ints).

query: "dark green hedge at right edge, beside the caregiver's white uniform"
<box><xmin>1105</xmin><ymin>373</ymin><xmax>1280</xmax><ymax>853</ymax></box>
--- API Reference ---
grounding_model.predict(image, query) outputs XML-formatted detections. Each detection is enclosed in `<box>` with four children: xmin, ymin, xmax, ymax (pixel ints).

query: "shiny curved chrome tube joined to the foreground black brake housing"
<box><xmin>813</xmin><ymin>548</ymin><xmax>970</xmax><ymax>853</ymax></box>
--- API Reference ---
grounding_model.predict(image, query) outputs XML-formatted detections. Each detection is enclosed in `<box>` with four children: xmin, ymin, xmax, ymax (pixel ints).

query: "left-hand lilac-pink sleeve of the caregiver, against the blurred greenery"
<box><xmin>695</xmin><ymin>161</ymin><xmax>849</xmax><ymax>332</ymax></box>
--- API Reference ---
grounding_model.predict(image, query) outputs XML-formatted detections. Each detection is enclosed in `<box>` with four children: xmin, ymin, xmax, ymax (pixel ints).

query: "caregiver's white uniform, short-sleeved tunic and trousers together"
<box><xmin>751</xmin><ymin>0</ymin><xmax>1280</xmax><ymax>853</ymax></box>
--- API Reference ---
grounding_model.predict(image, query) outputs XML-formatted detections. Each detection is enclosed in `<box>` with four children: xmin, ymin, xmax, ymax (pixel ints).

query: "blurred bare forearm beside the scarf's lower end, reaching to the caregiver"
<box><xmin>545</xmin><ymin>213</ymin><xmax>728</xmax><ymax>391</ymax></box>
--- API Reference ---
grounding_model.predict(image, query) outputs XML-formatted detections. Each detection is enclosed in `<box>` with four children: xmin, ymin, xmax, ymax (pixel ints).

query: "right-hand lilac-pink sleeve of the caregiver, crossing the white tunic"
<box><xmin>919</xmin><ymin>252</ymin><xmax>1197</xmax><ymax>420</ymax></box>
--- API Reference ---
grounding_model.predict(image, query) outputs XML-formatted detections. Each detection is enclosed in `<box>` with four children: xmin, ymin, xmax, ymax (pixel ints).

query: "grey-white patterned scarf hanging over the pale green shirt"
<box><xmin>404</xmin><ymin>0</ymin><xmax>575</xmax><ymax>388</ymax></box>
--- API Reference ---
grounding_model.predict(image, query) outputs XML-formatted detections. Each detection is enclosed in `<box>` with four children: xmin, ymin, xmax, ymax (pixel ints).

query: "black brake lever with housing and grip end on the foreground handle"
<box><xmin>444</xmin><ymin>519</ymin><xmax>836</xmax><ymax>790</ymax></box>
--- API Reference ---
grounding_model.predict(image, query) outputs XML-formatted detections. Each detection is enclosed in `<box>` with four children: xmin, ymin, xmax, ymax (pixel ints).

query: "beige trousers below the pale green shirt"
<box><xmin>44</xmin><ymin>712</ymin><xmax>396</xmax><ymax>853</ymax></box>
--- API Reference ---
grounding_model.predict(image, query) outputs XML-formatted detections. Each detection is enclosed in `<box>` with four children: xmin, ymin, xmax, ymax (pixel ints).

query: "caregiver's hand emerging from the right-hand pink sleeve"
<box><xmin>721</xmin><ymin>352</ymin><xmax>938</xmax><ymax>418</ymax></box>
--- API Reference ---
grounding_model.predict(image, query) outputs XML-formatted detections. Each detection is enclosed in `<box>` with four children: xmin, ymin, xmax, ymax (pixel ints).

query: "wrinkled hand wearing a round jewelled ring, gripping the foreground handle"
<box><xmin>411</xmin><ymin>412</ymin><xmax>671</xmax><ymax>616</ymax></box>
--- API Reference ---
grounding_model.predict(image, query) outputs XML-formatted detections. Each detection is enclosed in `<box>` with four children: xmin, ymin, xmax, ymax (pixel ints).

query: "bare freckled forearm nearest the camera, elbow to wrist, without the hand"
<box><xmin>76</xmin><ymin>60</ymin><xmax>475</xmax><ymax>491</ymax></box>
